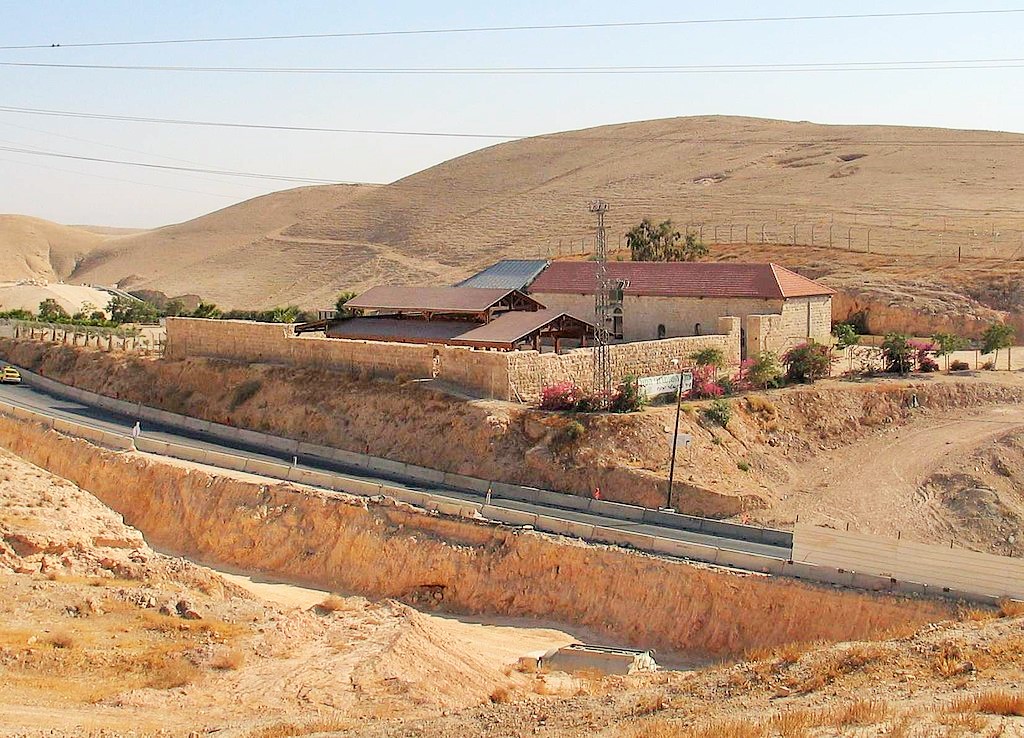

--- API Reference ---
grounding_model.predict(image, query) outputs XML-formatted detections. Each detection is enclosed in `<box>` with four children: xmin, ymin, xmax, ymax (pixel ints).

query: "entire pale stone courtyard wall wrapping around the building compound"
<box><xmin>166</xmin><ymin>317</ymin><xmax>740</xmax><ymax>402</ymax></box>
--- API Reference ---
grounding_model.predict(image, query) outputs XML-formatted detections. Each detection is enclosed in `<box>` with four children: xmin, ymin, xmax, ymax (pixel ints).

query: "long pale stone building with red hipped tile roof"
<box><xmin>526</xmin><ymin>261</ymin><xmax>834</xmax><ymax>355</ymax></box>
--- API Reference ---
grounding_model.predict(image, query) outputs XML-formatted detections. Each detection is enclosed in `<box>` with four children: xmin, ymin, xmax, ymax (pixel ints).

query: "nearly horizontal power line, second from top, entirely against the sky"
<box><xmin>0</xmin><ymin>58</ymin><xmax>1024</xmax><ymax>76</ymax></box>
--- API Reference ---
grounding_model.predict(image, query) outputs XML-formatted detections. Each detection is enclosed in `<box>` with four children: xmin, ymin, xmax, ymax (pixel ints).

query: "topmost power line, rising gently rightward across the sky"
<box><xmin>0</xmin><ymin>8</ymin><xmax>1024</xmax><ymax>50</ymax></box>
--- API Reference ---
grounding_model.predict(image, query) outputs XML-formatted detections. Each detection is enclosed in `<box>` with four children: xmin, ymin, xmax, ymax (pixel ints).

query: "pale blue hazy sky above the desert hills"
<box><xmin>0</xmin><ymin>0</ymin><xmax>1024</xmax><ymax>226</ymax></box>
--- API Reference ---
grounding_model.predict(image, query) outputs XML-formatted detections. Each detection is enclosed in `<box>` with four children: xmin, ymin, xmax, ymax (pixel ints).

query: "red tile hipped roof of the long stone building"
<box><xmin>529</xmin><ymin>261</ymin><xmax>835</xmax><ymax>302</ymax></box>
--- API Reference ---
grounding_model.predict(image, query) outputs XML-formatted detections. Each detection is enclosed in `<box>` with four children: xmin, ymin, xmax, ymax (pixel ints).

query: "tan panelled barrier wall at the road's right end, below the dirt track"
<box><xmin>793</xmin><ymin>523</ymin><xmax>1024</xmax><ymax>599</ymax></box>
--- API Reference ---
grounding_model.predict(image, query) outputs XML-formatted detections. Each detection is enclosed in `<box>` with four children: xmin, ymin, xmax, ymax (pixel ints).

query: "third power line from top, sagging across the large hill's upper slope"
<box><xmin>0</xmin><ymin>105</ymin><xmax>1024</xmax><ymax>146</ymax></box>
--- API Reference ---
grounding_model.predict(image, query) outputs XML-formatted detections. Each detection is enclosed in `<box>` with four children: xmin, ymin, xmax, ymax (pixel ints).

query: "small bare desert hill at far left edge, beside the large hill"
<box><xmin>0</xmin><ymin>215</ymin><xmax>121</xmax><ymax>281</ymax></box>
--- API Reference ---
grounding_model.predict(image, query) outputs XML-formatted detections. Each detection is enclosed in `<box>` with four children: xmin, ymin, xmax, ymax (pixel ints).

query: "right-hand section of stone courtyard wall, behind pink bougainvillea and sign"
<box><xmin>509</xmin><ymin>317</ymin><xmax>740</xmax><ymax>401</ymax></box>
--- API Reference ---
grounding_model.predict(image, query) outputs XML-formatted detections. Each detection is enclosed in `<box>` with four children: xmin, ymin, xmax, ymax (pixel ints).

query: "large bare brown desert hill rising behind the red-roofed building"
<box><xmin>56</xmin><ymin>117</ymin><xmax>1024</xmax><ymax>307</ymax></box>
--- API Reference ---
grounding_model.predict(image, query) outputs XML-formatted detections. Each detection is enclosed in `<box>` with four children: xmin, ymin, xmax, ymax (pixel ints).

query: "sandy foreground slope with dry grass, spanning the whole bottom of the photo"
<box><xmin>0</xmin><ymin>409</ymin><xmax>1024</xmax><ymax>738</ymax></box>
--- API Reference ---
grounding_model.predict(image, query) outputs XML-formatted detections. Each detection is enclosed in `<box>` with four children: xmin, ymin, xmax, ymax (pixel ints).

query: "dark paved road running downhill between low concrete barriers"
<box><xmin>0</xmin><ymin>384</ymin><xmax>792</xmax><ymax>560</ymax></box>
